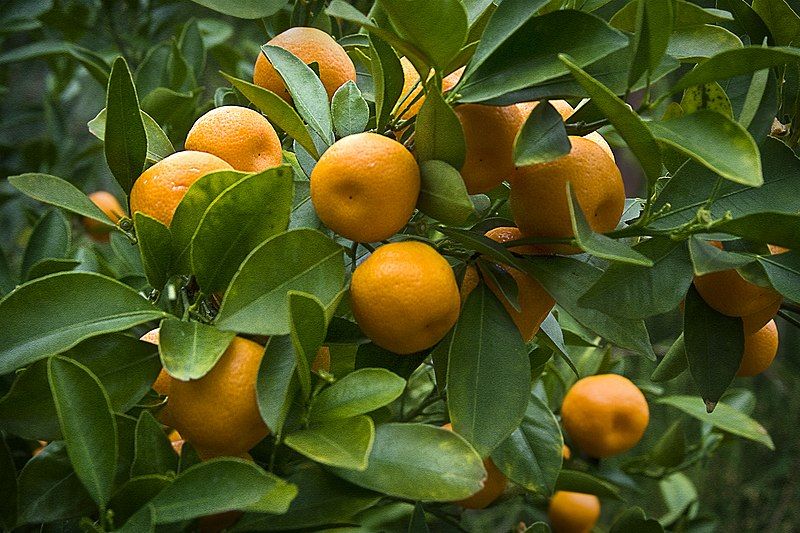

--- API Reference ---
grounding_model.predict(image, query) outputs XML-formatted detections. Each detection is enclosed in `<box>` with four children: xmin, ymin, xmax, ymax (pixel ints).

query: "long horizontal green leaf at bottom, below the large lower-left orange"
<box><xmin>150</xmin><ymin>457</ymin><xmax>297</xmax><ymax>524</ymax></box>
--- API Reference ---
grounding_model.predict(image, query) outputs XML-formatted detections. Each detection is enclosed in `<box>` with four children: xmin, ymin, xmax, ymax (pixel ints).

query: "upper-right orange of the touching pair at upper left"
<box><xmin>185</xmin><ymin>105</ymin><xmax>283</xmax><ymax>172</ymax></box>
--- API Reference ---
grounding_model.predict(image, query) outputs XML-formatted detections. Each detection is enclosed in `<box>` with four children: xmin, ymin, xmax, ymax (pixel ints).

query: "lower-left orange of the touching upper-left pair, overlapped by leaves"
<box><xmin>130</xmin><ymin>150</ymin><xmax>233</xmax><ymax>226</ymax></box>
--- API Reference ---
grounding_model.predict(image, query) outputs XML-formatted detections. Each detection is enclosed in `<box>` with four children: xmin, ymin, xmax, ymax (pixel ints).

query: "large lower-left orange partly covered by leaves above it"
<box><xmin>167</xmin><ymin>337</ymin><xmax>269</xmax><ymax>459</ymax></box>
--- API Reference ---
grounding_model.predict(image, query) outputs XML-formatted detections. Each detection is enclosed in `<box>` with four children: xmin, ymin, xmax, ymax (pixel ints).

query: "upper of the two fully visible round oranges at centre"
<box><xmin>311</xmin><ymin>133</ymin><xmax>420</xmax><ymax>242</ymax></box>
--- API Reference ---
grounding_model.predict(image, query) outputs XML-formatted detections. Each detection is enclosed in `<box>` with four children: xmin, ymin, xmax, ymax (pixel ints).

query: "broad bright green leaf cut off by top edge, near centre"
<box><xmin>378</xmin><ymin>0</ymin><xmax>468</xmax><ymax>70</ymax></box>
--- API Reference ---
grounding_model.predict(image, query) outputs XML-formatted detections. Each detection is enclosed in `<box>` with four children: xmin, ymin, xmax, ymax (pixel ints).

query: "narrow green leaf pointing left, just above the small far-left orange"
<box><xmin>8</xmin><ymin>173</ymin><xmax>114</xmax><ymax>226</ymax></box>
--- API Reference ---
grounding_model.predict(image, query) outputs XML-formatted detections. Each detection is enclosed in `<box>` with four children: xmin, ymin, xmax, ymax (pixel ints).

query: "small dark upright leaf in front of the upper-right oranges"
<box><xmin>514</xmin><ymin>101</ymin><xmax>572</xmax><ymax>167</ymax></box>
